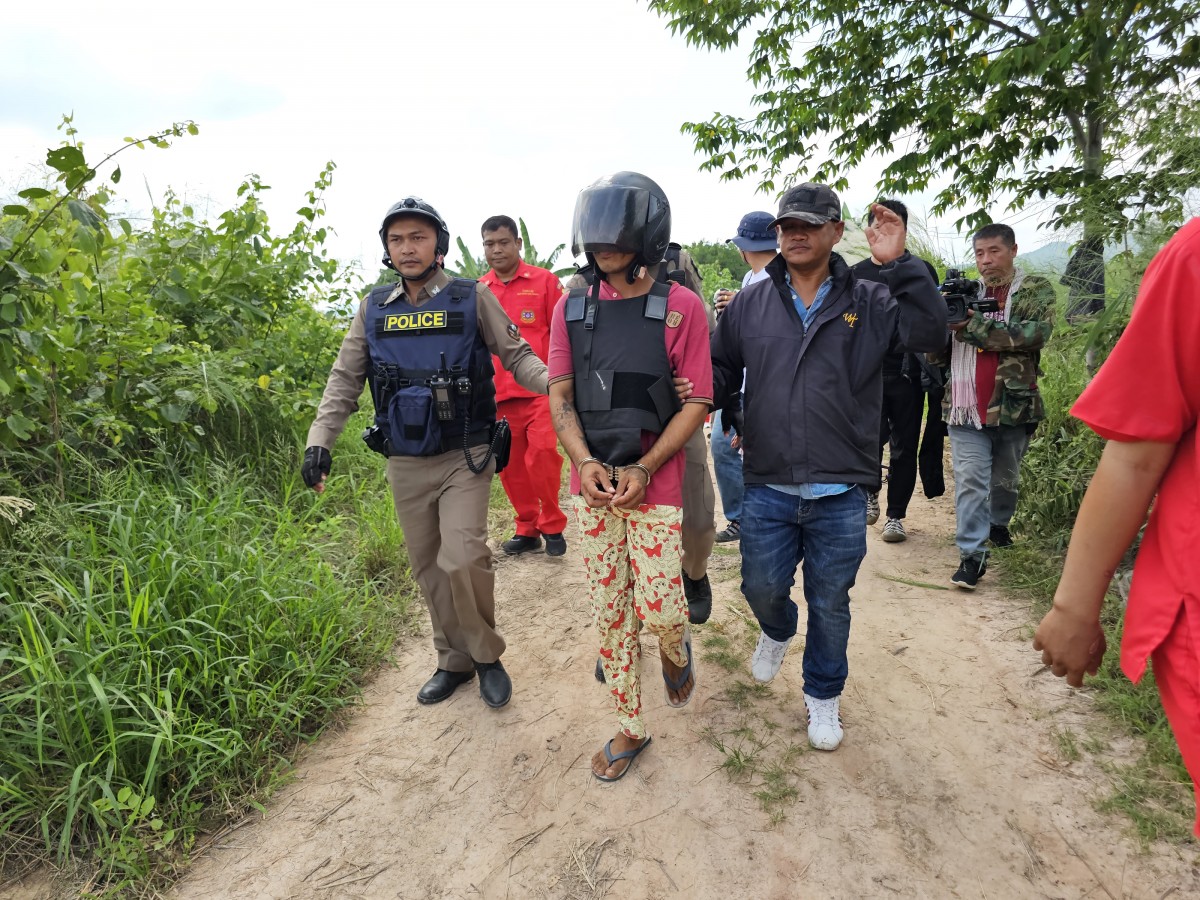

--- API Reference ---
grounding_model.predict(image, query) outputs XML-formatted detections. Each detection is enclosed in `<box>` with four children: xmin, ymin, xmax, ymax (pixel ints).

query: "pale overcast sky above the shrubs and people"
<box><xmin>7</xmin><ymin>0</ymin><xmax>1052</xmax><ymax>282</ymax></box>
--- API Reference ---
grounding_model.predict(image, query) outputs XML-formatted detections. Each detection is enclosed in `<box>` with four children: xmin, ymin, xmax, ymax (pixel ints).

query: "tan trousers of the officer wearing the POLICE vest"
<box><xmin>388</xmin><ymin>448</ymin><xmax>504</xmax><ymax>672</ymax></box>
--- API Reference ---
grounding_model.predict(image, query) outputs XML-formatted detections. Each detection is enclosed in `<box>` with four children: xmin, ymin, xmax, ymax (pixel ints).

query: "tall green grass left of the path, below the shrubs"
<box><xmin>0</xmin><ymin>427</ymin><xmax>413</xmax><ymax>894</ymax></box>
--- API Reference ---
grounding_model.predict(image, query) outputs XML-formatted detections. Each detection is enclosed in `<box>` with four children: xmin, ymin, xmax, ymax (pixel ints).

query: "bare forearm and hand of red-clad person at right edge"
<box><xmin>1033</xmin><ymin>440</ymin><xmax>1175</xmax><ymax>688</ymax></box>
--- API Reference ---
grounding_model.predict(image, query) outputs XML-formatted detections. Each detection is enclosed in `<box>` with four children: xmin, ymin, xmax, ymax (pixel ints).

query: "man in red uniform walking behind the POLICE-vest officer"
<box><xmin>479</xmin><ymin>216</ymin><xmax>566</xmax><ymax>557</ymax></box>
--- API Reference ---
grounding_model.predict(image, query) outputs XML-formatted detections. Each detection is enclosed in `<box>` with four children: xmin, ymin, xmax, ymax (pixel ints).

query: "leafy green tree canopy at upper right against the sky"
<box><xmin>649</xmin><ymin>0</ymin><xmax>1200</xmax><ymax>238</ymax></box>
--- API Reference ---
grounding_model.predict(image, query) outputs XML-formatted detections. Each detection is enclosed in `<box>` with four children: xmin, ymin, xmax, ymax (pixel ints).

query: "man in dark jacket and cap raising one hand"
<box><xmin>712</xmin><ymin>184</ymin><xmax>947</xmax><ymax>750</ymax></box>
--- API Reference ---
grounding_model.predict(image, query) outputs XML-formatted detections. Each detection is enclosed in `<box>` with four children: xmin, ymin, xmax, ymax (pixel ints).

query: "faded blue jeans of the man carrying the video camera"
<box><xmin>949</xmin><ymin>425</ymin><xmax>1030</xmax><ymax>559</ymax></box>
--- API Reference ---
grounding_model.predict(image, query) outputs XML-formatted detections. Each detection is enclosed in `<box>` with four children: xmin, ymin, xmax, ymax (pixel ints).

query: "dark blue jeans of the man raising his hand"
<box><xmin>742</xmin><ymin>485</ymin><xmax>866</xmax><ymax>700</ymax></box>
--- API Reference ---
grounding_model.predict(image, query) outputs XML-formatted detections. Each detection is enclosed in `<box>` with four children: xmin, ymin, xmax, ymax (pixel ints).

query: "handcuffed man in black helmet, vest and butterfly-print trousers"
<box><xmin>548</xmin><ymin>172</ymin><xmax>713</xmax><ymax>781</ymax></box>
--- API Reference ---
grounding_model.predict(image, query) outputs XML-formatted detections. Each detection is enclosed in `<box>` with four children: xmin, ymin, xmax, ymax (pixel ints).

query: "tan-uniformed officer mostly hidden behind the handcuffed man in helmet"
<box><xmin>566</xmin><ymin>241</ymin><xmax>716</xmax><ymax>628</ymax></box>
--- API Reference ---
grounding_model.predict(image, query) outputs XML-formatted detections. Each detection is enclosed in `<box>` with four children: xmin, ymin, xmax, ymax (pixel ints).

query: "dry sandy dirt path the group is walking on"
<box><xmin>173</xmin><ymin>489</ymin><xmax>1200</xmax><ymax>900</ymax></box>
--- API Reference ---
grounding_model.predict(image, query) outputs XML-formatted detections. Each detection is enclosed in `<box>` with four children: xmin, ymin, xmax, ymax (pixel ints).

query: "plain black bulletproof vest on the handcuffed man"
<box><xmin>565</xmin><ymin>282</ymin><xmax>679</xmax><ymax>466</ymax></box>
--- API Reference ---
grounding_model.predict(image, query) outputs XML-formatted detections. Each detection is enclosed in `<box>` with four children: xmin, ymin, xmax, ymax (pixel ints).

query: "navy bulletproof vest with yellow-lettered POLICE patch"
<box><xmin>364</xmin><ymin>278</ymin><xmax>496</xmax><ymax>456</ymax></box>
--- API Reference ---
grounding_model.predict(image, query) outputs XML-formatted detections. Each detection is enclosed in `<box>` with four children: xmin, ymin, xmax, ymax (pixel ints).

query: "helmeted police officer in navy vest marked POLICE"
<box><xmin>301</xmin><ymin>197</ymin><xmax>546</xmax><ymax>708</ymax></box>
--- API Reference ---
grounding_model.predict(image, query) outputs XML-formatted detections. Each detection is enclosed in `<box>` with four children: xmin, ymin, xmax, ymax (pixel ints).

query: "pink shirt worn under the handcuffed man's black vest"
<box><xmin>546</xmin><ymin>282</ymin><xmax>713</xmax><ymax>506</ymax></box>
